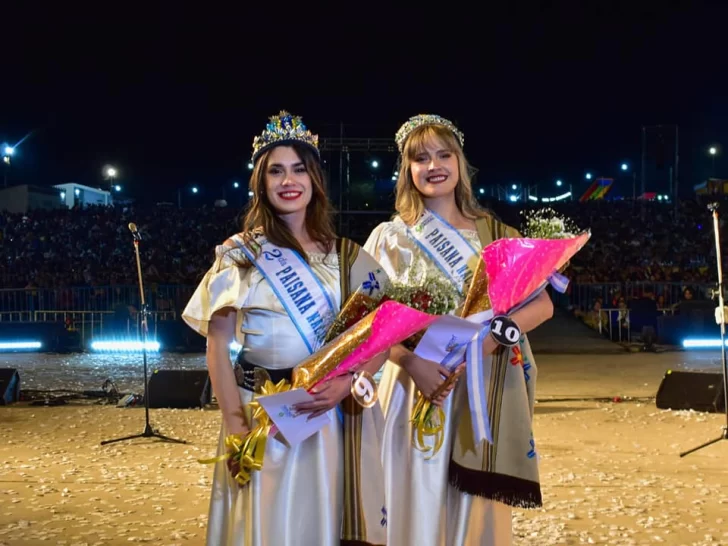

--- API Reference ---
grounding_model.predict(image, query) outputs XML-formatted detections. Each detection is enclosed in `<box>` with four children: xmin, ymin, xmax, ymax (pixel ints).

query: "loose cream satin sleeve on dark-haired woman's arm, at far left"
<box><xmin>182</xmin><ymin>240</ymin><xmax>252</xmax><ymax>337</ymax></box>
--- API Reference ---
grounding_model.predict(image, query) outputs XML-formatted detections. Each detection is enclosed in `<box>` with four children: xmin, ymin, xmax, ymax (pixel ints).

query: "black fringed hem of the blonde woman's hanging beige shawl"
<box><xmin>449</xmin><ymin>461</ymin><xmax>543</xmax><ymax>508</ymax></box>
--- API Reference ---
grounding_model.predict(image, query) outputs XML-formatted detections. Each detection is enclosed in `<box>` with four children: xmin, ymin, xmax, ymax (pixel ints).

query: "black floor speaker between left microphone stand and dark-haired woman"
<box><xmin>147</xmin><ymin>370</ymin><xmax>211</xmax><ymax>408</ymax></box>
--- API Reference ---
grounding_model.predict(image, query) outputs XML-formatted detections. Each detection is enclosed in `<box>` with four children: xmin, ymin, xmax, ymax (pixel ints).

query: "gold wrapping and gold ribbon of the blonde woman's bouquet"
<box><xmin>410</xmin><ymin>259</ymin><xmax>492</xmax><ymax>458</ymax></box>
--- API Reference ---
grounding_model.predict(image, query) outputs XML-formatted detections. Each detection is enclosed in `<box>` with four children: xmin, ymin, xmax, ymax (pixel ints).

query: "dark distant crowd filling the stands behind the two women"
<box><xmin>0</xmin><ymin>201</ymin><xmax>715</xmax><ymax>289</ymax></box>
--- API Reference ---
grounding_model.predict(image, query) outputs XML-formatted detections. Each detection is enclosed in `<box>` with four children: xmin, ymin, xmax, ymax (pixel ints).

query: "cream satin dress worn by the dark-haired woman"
<box><xmin>182</xmin><ymin>238</ymin><xmax>344</xmax><ymax>546</ymax></box>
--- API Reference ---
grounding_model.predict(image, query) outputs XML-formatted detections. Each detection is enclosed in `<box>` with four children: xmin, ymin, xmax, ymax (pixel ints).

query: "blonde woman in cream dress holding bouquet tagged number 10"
<box><xmin>364</xmin><ymin>115</ymin><xmax>553</xmax><ymax>546</ymax></box>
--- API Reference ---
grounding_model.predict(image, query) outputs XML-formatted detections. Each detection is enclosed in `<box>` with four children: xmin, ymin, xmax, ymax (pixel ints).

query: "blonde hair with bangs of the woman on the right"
<box><xmin>394</xmin><ymin>125</ymin><xmax>489</xmax><ymax>225</ymax></box>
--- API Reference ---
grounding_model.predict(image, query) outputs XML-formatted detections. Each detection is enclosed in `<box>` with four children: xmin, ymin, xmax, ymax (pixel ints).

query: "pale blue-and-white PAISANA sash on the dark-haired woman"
<box><xmin>236</xmin><ymin>236</ymin><xmax>336</xmax><ymax>354</ymax></box>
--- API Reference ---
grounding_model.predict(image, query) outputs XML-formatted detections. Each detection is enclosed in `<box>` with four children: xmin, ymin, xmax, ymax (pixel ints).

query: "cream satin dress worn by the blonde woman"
<box><xmin>364</xmin><ymin>218</ymin><xmax>512</xmax><ymax>546</ymax></box>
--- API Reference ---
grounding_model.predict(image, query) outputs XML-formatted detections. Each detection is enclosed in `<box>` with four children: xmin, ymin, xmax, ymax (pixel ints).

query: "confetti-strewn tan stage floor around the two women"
<box><xmin>0</xmin><ymin>346</ymin><xmax>728</xmax><ymax>546</ymax></box>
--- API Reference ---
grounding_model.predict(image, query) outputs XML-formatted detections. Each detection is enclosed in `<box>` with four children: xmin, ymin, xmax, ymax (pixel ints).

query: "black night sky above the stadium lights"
<box><xmin>0</xmin><ymin>1</ymin><xmax>728</xmax><ymax>201</ymax></box>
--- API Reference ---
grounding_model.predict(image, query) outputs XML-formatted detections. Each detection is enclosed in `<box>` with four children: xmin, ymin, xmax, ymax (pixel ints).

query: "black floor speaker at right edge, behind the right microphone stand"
<box><xmin>655</xmin><ymin>370</ymin><xmax>725</xmax><ymax>413</ymax></box>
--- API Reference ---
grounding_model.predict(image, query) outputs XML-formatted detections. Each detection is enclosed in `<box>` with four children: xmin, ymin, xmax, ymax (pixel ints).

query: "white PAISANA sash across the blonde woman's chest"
<box><xmin>407</xmin><ymin>209</ymin><xmax>478</xmax><ymax>294</ymax></box>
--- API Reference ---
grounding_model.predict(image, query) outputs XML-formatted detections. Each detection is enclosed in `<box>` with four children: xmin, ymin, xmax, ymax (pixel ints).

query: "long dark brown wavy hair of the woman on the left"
<box><xmin>242</xmin><ymin>142</ymin><xmax>336</xmax><ymax>261</ymax></box>
